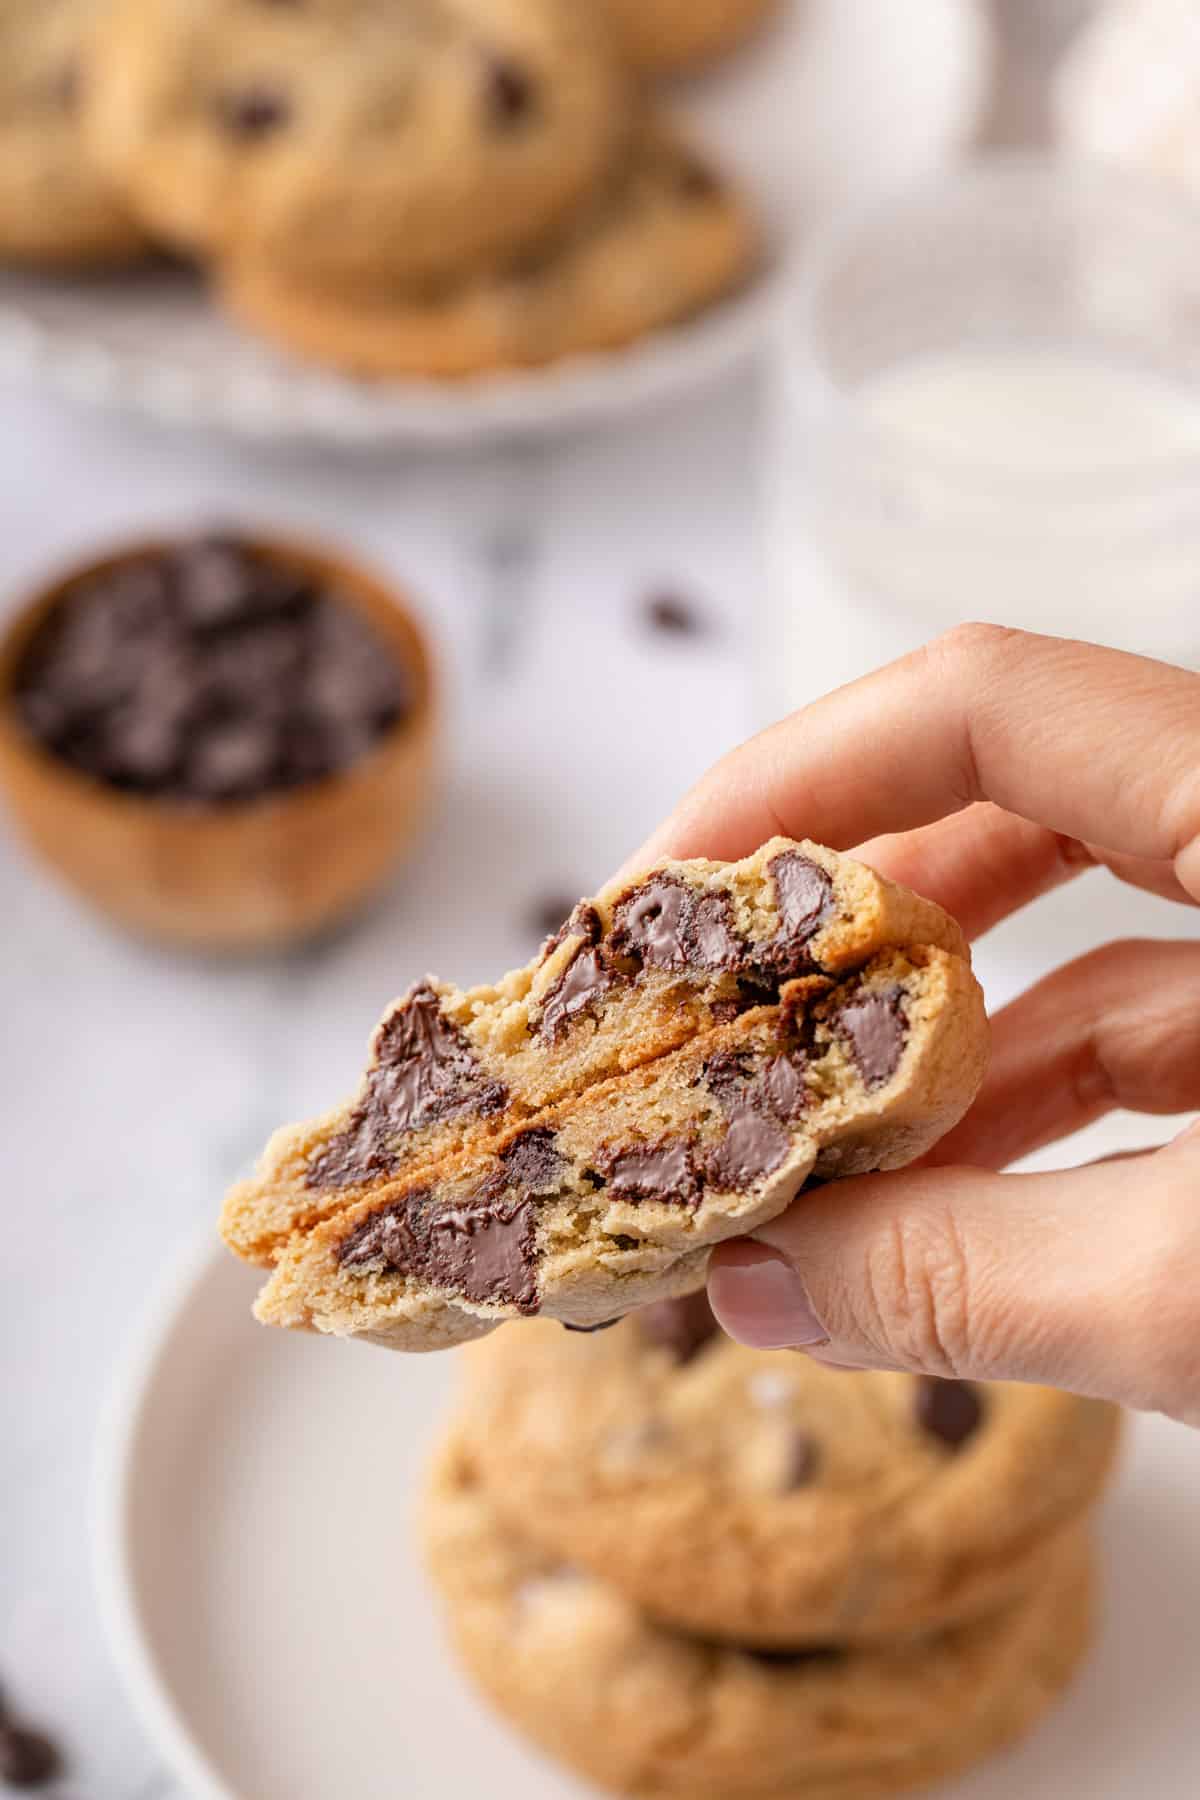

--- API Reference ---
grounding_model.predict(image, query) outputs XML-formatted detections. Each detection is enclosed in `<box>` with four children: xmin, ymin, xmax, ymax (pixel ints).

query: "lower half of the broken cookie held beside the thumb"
<box><xmin>246</xmin><ymin>943</ymin><xmax>986</xmax><ymax>1350</ymax></box>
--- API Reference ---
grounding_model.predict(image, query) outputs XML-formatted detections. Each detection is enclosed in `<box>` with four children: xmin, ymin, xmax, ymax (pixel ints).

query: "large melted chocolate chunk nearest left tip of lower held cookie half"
<box><xmin>338</xmin><ymin>1177</ymin><xmax>538</xmax><ymax>1312</ymax></box>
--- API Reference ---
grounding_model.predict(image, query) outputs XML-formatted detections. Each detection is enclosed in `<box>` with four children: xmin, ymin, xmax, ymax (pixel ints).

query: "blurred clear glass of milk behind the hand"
<box><xmin>759</xmin><ymin>155</ymin><xmax>1200</xmax><ymax>715</ymax></box>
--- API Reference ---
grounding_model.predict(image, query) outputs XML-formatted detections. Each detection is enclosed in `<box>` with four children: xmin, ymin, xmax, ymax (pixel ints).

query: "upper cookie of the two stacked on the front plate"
<box><xmin>455</xmin><ymin>1292</ymin><xmax>1121</xmax><ymax>1647</ymax></box>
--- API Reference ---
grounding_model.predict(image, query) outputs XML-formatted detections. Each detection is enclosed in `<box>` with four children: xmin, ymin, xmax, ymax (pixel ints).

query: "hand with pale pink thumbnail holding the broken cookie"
<box><xmin>633</xmin><ymin>625</ymin><xmax>1200</xmax><ymax>1426</ymax></box>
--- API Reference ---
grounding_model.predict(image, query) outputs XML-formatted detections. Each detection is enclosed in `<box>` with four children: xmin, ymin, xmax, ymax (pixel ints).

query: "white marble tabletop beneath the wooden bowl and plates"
<box><xmin>0</xmin><ymin>343</ymin><xmax>1195</xmax><ymax>1800</ymax></box>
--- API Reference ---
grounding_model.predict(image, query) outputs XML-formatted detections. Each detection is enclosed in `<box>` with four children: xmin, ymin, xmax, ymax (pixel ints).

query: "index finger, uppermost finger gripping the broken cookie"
<box><xmin>637</xmin><ymin>625</ymin><xmax>1200</xmax><ymax>896</ymax></box>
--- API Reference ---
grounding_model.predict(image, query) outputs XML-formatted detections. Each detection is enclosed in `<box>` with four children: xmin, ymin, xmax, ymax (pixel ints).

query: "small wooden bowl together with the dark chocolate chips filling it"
<box><xmin>0</xmin><ymin>535</ymin><xmax>435</xmax><ymax>950</ymax></box>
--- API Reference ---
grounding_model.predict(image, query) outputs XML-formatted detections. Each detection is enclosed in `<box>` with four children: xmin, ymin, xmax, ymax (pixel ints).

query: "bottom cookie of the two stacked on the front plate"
<box><xmin>425</xmin><ymin>1435</ymin><xmax>1092</xmax><ymax>1800</ymax></box>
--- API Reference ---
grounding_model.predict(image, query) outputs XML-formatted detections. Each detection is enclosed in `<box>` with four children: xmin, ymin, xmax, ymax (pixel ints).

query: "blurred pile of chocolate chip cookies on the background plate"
<box><xmin>0</xmin><ymin>0</ymin><xmax>765</xmax><ymax>376</ymax></box>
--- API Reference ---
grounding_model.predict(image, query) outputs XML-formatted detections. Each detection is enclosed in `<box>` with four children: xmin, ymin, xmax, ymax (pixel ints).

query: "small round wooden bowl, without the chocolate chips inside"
<box><xmin>0</xmin><ymin>535</ymin><xmax>437</xmax><ymax>950</ymax></box>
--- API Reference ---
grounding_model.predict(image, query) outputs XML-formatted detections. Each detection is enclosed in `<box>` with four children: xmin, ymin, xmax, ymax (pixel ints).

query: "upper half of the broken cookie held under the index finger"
<box><xmin>221</xmin><ymin>837</ymin><xmax>984</xmax><ymax>1267</ymax></box>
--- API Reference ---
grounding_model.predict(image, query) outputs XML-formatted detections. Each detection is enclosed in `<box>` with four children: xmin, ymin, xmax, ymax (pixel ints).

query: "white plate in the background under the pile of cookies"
<box><xmin>0</xmin><ymin>0</ymin><xmax>988</xmax><ymax>443</ymax></box>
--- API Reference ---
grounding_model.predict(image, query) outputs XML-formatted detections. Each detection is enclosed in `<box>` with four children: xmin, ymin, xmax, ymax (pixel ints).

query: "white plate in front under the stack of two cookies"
<box><xmin>97</xmin><ymin>1121</ymin><xmax>1200</xmax><ymax>1800</ymax></box>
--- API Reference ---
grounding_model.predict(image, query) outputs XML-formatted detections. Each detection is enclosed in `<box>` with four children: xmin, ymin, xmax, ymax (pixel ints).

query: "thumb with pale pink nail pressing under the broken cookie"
<box><xmin>709</xmin><ymin>1127</ymin><xmax>1200</xmax><ymax>1422</ymax></box>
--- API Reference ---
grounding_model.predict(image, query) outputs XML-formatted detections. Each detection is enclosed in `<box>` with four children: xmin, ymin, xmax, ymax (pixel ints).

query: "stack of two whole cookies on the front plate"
<box><xmin>425</xmin><ymin>1294</ymin><xmax>1119</xmax><ymax>1800</ymax></box>
